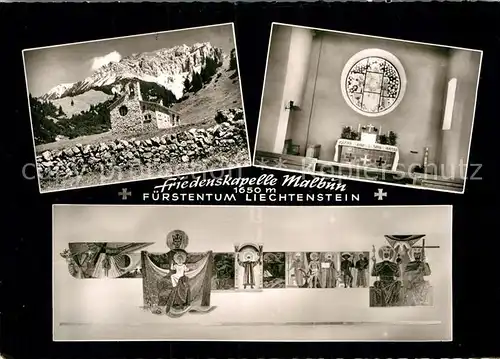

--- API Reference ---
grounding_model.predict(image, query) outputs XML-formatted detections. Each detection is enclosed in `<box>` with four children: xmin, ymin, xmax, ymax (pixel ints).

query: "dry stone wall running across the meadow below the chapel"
<box><xmin>36</xmin><ymin>109</ymin><xmax>247</xmax><ymax>180</ymax></box>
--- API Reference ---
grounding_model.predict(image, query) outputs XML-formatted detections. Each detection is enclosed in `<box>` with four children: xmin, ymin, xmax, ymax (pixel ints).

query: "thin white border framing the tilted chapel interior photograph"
<box><xmin>252</xmin><ymin>22</ymin><xmax>483</xmax><ymax>194</ymax></box>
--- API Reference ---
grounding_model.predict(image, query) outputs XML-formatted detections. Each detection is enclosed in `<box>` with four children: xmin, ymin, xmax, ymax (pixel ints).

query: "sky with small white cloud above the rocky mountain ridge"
<box><xmin>24</xmin><ymin>24</ymin><xmax>235</xmax><ymax>96</ymax></box>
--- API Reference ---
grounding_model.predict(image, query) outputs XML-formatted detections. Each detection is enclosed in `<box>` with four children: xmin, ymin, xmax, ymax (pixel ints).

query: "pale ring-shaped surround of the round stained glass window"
<box><xmin>340</xmin><ymin>49</ymin><xmax>407</xmax><ymax>117</ymax></box>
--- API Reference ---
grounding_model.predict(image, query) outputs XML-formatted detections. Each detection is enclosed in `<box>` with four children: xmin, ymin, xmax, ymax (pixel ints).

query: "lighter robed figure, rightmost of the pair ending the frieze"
<box><xmin>402</xmin><ymin>248</ymin><xmax>431</xmax><ymax>306</ymax></box>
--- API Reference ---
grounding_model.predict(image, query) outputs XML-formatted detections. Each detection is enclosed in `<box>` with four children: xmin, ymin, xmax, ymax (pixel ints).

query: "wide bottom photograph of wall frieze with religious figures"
<box><xmin>52</xmin><ymin>204</ymin><xmax>452</xmax><ymax>341</ymax></box>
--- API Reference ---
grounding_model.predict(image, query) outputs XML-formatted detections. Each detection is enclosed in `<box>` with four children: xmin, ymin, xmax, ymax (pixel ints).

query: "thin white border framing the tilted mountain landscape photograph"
<box><xmin>22</xmin><ymin>22</ymin><xmax>252</xmax><ymax>194</ymax></box>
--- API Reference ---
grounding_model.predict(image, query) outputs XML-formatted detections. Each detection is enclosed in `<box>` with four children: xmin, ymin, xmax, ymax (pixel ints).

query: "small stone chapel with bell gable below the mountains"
<box><xmin>109</xmin><ymin>81</ymin><xmax>180</xmax><ymax>134</ymax></box>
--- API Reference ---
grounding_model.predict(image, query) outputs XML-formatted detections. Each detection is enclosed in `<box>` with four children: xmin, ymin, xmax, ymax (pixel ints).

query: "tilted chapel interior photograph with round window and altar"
<box><xmin>254</xmin><ymin>23</ymin><xmax>483</xmax><ymax>193</ymax></box>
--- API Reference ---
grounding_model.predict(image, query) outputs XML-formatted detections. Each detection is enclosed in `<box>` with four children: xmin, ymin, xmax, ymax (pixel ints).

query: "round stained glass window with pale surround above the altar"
<box><xmin>341</xmin><ymin>49</ymin><xmax>406</xmax><ymax>117</ymax></box>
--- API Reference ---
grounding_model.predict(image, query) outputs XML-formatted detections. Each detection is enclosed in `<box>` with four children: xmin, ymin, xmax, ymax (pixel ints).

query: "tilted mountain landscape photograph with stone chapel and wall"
<box><xmin>23</xmin><ymin>23</ymin><xmax>250</xmax><ymax>193</ymax></box>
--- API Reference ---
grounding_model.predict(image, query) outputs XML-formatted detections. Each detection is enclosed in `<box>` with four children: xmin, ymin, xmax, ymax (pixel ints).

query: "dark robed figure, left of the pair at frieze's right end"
<box><xmin>370</xmin><ymin>246</ymin><xmax>401</xmax><ymax>307</ymax></box>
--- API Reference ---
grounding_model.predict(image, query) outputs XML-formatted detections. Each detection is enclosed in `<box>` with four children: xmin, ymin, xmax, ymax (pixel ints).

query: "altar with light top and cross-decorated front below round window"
<box><xmin>333</xmin><ymin>137</ymin><xmax>399</xmax><ymax>171</ymax></box>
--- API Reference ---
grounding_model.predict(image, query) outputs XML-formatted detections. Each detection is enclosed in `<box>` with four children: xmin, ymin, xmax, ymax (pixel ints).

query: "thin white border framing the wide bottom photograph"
<box><xmin>52</xmin><ymin>203</ymin><xmax>454</xmax><ymax>343</ymax></box>
